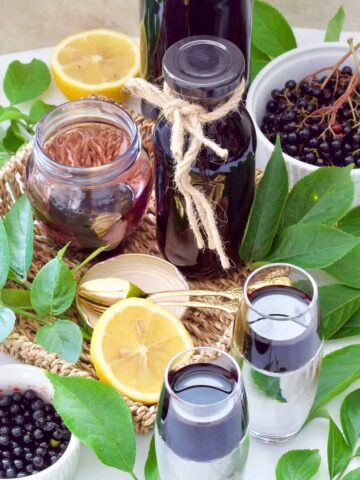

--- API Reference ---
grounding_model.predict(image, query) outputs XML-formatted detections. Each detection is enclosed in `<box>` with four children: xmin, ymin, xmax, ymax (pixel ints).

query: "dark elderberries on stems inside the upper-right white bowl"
<box><xmin>261</xmin><ymin>66</ymin><xmax>360</xmax><ymax>168</ymax></box>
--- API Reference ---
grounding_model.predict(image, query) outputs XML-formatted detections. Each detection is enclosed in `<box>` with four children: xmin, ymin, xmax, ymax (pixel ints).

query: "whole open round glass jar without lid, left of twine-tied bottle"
<box><xmin>26</xmin><ymin>100</ymin><xmax>153</xmax><ymax>250</ymax></box>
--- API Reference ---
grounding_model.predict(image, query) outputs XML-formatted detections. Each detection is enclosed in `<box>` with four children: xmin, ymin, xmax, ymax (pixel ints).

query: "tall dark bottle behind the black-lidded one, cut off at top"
<box><xmin>140</xmin><ymin>0</ymin><xmax>253</xmax><ymax>118</ymax></box>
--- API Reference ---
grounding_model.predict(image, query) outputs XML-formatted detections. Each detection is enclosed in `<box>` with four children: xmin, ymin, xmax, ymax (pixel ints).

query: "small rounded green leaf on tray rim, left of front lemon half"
<box><xmin>36</xmin><ymin>320</ymin><xmax>83</xmax><ymax>363</ymax></box>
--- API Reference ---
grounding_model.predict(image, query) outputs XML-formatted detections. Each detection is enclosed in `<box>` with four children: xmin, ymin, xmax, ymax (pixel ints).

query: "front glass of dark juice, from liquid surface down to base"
<box><xmin>156</xmin><ymin>361</ymin><xmax>248</xmax><ymax>480</ymax></box>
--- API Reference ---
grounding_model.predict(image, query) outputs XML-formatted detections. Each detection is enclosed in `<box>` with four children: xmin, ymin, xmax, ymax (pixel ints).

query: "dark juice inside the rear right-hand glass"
<box><xmin>234</xmin><ymin>285</ymin><xmax>321</xmax><ymax>373</ymax></box>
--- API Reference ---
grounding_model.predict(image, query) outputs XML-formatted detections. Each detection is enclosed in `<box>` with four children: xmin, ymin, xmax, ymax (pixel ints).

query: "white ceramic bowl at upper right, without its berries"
<box><xmin>246</xmin><ymin>42</ymin><xmax>360</xmax><ymax>205</ymax></box>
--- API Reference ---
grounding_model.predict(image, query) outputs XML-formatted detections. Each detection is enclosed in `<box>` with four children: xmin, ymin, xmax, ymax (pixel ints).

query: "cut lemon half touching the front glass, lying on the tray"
<box><xmin>91</xmin><ymin>298</ymin><xmax>193</xmax><ymax>404</ymax></box>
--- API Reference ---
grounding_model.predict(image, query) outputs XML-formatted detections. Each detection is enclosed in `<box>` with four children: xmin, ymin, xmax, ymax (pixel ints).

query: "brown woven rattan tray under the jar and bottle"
<box><xmin>0</xmin><ymin>107</ymin><xmax>256</xmax><ymax>433</ymax></box>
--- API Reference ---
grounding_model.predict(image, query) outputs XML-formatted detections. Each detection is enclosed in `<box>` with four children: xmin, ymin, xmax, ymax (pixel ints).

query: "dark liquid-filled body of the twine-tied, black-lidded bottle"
<box><xmin>154</xmin><ymin>108</ymin><xmax>256</xmax><ymax>278</ymax></box>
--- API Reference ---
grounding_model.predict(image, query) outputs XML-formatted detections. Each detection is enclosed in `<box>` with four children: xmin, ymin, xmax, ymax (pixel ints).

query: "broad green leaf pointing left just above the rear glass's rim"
<box><xmin>267</xmin><ymin>223</ymin><xmax>359</xmax><ymax>269</ymax></box>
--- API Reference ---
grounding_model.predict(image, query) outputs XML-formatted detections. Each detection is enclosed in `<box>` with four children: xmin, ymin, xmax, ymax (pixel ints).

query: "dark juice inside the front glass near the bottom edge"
<box><xmin>157</xmin><ymin>363</ymin><xmax>248</xmax><ymax>462</ymax></box>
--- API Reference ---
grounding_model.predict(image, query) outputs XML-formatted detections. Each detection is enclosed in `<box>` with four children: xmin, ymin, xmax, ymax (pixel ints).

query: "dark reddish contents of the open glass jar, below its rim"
<box><xmin>27</xmin><ymin>121</ymin><xmax>152</xmax><ymax>253</ymax></box>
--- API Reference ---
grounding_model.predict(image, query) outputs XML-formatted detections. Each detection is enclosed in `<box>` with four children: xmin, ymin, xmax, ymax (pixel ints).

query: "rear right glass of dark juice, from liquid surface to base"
<box><xmin>233</xmin><ymin>285</ymin><xmax>322</xmax><ymax>442</ymax></box>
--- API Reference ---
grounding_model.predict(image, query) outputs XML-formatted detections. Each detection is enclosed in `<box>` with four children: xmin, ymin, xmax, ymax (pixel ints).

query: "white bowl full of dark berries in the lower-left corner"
<box><xmin>0</xmin><ymin>365</ymin><xmax>80</xmax><ymax>480</ymax></box>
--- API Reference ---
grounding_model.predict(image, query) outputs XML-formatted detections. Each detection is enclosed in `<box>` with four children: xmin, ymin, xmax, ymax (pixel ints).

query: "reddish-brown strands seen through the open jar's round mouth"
<box><xmin>44</xmin><ymin>122</ymin><xmax>130</xmax><ymax>168</ymax></box>
